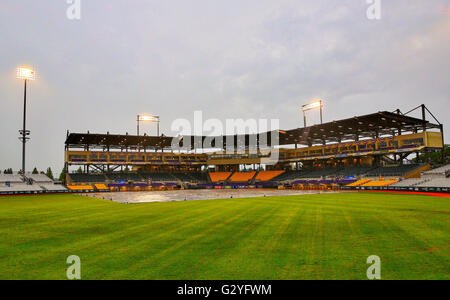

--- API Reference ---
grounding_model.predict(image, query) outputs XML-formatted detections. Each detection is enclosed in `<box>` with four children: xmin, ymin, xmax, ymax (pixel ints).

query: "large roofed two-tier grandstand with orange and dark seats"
<box><xmin>59</xmin><ymin>105</ymin><xmax>449</xmax><ymax>195</ymax></box>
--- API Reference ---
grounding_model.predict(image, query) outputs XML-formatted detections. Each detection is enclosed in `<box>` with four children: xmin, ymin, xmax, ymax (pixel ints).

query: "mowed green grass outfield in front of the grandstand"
<box><xmin>0</xmin><ymin>193</ymin><xmax>450</xmax><ymax>279</ymax></box>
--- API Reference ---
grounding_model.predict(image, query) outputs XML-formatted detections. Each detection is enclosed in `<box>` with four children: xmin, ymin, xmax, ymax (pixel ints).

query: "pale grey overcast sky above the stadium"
<box><xmin>0</xmin><ymin>0</ymin><xmax>450</xmax><ymax>172</ymax></box>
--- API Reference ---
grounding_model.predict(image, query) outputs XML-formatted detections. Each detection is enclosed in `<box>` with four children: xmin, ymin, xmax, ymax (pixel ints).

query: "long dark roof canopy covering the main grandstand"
<box><xmin>65</xmin><ymin>111</ymin><xmax>440</xmax><ymax>150</ymax></box>
